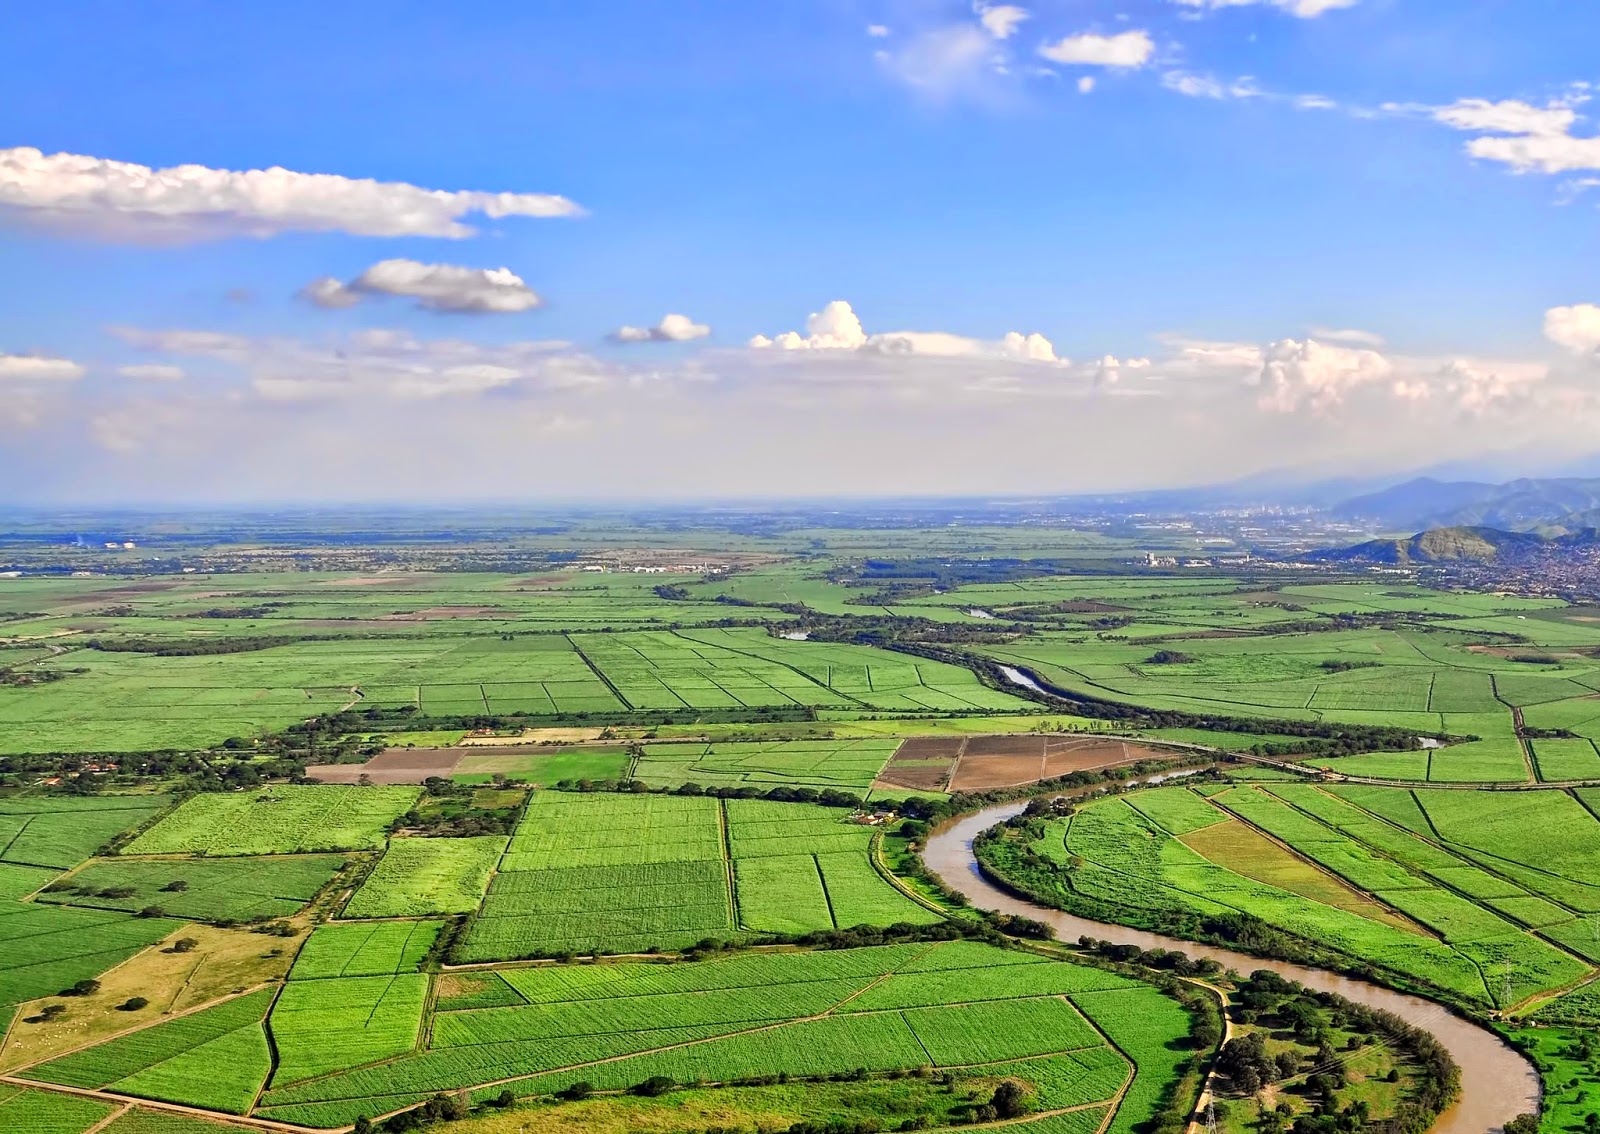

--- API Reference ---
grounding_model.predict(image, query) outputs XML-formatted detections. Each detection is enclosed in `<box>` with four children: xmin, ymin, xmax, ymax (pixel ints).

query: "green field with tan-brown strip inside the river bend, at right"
<box><xmin>992</xmin><ymin>784</ymin><xmax>1600</xmax><ymax>1008</ymax></box>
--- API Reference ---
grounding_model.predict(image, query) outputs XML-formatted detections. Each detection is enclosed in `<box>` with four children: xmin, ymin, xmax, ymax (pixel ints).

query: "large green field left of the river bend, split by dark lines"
<box><xmin>461</xmin><ymin>792</ymin><xmax>938</xmax><ymax>961</ymax></box>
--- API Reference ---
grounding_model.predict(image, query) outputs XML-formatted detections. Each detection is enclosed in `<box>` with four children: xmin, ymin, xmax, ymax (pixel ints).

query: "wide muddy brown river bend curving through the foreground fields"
<box><xmin>922</xmin><ymin>803</ymin><xmax>1539</xmax><ymax>1134</ymax></box>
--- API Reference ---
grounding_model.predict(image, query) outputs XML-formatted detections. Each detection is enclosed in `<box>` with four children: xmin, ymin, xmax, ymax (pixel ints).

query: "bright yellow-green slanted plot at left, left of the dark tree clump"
<box><xmin>126</xmin><ymin>785</ymin><xmax>419</xmax><ymax>856</ymax></box>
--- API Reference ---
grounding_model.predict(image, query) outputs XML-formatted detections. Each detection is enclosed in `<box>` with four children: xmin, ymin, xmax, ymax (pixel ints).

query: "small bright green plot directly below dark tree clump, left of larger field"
<box><xmin>341</xmin><ymin>835</ymin><xmax>507</xmax><ymax>918</ymax></box>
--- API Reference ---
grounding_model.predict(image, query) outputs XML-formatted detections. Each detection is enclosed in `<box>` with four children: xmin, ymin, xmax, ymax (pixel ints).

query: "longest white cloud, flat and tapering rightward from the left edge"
<box><xmin>0</xmin><ymin>146</ymin><xmax>582</xmax><ymax>240</ymax></box>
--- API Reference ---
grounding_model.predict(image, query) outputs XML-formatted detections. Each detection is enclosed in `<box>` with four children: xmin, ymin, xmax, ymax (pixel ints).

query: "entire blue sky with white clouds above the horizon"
<box><xmin>0</xmin><ymin>0</ymin><xmax>1600</xmax><ymax>501</ymax></box>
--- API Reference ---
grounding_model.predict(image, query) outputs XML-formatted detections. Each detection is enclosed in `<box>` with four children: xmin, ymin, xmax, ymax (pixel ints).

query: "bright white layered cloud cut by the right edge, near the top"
<box><xmin>1433</xmin><ymin>94</ymin><xmax>1600</xmax><ymax>173</ymax></box>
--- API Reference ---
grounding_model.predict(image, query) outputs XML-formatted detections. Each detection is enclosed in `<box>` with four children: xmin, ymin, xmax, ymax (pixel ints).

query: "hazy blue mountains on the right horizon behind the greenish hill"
<box><xmin>1331</xmin><ymin>477</ymin><xmax>1600</xmax><ymax>536</ymax></box>
